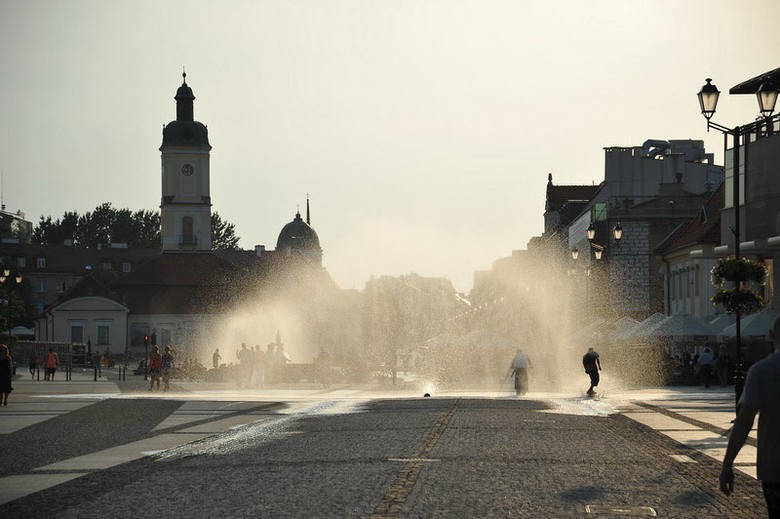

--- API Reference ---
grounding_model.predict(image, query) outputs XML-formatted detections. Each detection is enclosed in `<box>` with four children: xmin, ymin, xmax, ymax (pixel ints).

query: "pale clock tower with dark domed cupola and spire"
<box><xmin>160</xmin><ymin>73</ymin><xmax>211</xmax><ymax>252</ymax></box>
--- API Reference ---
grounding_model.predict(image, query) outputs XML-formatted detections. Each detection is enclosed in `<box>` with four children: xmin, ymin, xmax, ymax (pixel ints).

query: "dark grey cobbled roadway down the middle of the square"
<box><xmin>0</xmin><ymin>398</ymin><xmax>766</xmax><ymax>518</ymax></box>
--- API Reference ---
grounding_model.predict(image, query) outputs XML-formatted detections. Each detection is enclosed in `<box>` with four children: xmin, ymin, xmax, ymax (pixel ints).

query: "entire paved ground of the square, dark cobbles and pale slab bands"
<box><xmin>0</xmin><ymin>383</ymin><xmax>766</xmax><ymax>518</ymax></box>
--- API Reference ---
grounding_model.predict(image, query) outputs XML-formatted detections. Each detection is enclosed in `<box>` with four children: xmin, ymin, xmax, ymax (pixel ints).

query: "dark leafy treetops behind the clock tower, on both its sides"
<box><xmin>32</xmin><ymin>202</ymin><xmax>239</xmax><ymax>249</ymax></box>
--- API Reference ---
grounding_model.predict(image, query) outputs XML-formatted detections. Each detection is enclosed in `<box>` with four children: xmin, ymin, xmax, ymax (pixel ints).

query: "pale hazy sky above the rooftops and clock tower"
<box><xmin>0</xmin><ymin>0</ymin><xmax>780</xmax><ymax>292</ymax></box>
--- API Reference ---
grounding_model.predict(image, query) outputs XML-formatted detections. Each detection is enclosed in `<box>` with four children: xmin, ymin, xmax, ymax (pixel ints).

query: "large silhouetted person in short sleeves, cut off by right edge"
<box><xmin>720</xmin><ymin>316</ymin><xmax>780</xmax><ymax>519</ymax></box>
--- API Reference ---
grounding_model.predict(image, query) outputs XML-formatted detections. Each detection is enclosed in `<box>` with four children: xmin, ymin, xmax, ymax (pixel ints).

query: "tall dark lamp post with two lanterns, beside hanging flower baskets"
<box><xmin>697</xmin><ymin>78</ymin><xmax>778</xmax><ymax>404</ymax></box>
